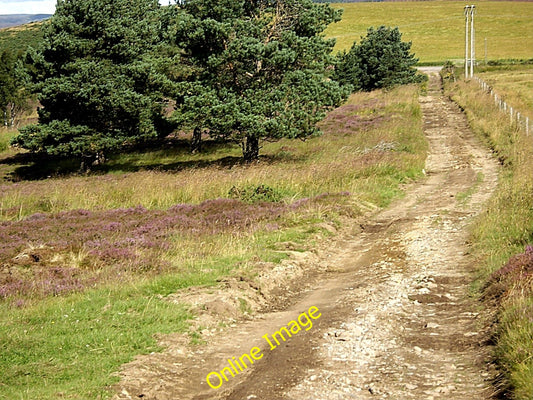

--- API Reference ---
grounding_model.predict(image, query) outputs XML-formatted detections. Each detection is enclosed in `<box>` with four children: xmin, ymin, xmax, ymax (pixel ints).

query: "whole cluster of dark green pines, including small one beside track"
<box><xmin>6</xmin><ymin>0</ymin><xmax>417</xmax><ymax>165</ymax></box>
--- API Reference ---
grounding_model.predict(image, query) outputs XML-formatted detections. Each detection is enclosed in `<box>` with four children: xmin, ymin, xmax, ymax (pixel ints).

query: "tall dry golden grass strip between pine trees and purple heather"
<box><xmin>0</xmin><ymin>86</ymin><xmax>426</xmax><ymax>220</ymax></box>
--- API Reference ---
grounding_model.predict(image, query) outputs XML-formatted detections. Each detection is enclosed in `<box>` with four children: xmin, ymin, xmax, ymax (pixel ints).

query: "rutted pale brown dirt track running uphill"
<box><xmin>111</xmin><ymin>69</ymin><xmax>498</xmax><ymax>400</ymax></box>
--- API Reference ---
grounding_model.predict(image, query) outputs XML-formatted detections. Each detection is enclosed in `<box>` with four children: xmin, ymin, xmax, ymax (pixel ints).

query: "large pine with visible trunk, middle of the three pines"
<box><xmin>176</xmin><ymin>0</ymin><xmax>347</xmax><ymax>161</ymax></box>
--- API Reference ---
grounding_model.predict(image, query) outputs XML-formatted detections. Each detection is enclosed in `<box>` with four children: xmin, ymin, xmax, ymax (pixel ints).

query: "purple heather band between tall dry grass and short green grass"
<box><xmin>0</xmin><ymin>199</ymin><xmax>288</xmax><ymax>298</ymax></box>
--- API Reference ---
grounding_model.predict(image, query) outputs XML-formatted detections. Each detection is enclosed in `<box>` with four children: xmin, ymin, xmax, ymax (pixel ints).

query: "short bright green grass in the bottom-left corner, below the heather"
<box><xmin>0</xmin><ymin>286</ymin><xmax>190</xmax><ymax>400</ymax></box>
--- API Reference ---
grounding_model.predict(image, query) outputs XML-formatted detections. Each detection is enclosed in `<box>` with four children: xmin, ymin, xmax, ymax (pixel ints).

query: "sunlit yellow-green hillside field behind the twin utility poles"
<box><xmin>326</xmin><ymin>1</ymin><xmax>533</xmax><ymax>63</ymax></box>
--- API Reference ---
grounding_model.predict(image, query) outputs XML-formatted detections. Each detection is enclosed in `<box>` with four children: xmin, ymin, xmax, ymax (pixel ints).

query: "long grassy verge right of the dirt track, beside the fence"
<box><xmin>440</xmin><ymin>67</ymin><xmax>533</xmax><ymax>400</ymax></box>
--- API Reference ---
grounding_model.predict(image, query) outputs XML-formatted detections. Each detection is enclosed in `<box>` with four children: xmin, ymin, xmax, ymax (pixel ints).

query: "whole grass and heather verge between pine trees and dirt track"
<box><xmin>0</xmin><ymin>86</ymin><xmax>427</xmax><ymax>399</ymax></box>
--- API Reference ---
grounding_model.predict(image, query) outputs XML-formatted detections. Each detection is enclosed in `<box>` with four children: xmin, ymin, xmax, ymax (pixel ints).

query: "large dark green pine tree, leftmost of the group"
<box><xmin>14</xmin><ymin>0</ymin><xmax>172</xmax><ymax>165</ymax></box>
